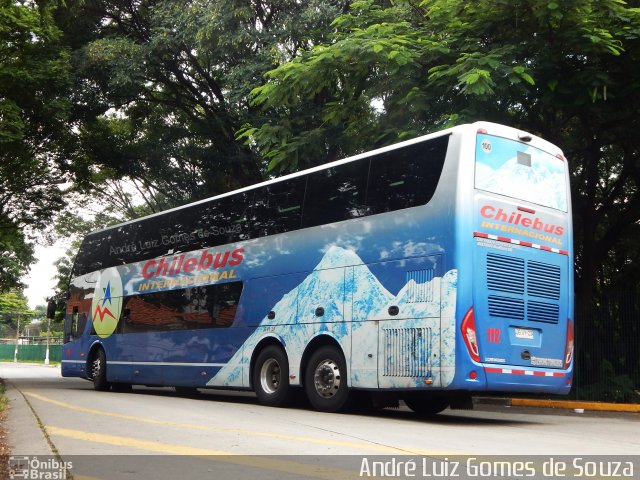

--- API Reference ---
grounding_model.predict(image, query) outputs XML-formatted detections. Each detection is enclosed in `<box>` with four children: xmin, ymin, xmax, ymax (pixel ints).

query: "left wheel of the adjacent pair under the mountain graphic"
<box><xmin>253</xmin><ymin>345</ymin><xmax>291</xmax><ymax>407</ymax></box>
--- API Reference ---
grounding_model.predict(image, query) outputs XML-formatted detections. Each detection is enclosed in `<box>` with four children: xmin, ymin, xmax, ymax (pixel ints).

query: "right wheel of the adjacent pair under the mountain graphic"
<box><xmin>304</xmin><ymin>345</ymin><xmax>352</xmax><ymax>412</ymax></box>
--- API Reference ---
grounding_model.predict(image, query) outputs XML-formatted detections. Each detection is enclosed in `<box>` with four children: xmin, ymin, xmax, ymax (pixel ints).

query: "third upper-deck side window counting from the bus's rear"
<box><xmin>251</xmin><ymin>177</ymin><xmax>306</xmax><ymax>237</ymax></box>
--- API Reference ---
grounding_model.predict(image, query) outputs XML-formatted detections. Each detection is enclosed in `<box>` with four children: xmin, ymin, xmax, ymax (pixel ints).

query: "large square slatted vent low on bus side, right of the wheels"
<box><xmin>383</xmin><ymin>328</ymin><xmax>431</xmax><ymax>377</ymax></box>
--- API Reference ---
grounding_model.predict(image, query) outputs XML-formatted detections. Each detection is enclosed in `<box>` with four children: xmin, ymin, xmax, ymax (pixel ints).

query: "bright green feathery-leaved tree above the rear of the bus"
<box><xmin>248</xmin><ymin>0</ymin><xmax>640</xmax><ymax>298</ymax></box>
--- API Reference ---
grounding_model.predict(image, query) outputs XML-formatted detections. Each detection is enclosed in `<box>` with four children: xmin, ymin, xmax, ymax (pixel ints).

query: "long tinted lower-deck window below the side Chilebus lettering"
<box><xmin>119</xmin><ymin>282</ymin><xmax>242</xmax><ymax>333</ymax></box>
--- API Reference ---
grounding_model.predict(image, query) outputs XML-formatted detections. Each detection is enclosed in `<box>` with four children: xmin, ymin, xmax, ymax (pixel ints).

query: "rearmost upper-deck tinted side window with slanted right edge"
<box><xmin>367</xmin><ymin>135</ymin><xmax>449</xmax><ymax>215</ymax></box>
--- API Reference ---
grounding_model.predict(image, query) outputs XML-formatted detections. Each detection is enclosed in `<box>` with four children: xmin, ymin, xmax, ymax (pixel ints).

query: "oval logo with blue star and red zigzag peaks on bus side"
<box><xmin>91</xmin><ymin>267</ymin><xmax>122</xmax><ymax>338</ymax></box>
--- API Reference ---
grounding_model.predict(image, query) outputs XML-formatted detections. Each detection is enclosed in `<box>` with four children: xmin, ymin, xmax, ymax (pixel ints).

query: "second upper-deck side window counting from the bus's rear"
<box><xmin>302</xmin><ymin>160</ymin><xmax>369</xmax><ymax>228</ymax></box>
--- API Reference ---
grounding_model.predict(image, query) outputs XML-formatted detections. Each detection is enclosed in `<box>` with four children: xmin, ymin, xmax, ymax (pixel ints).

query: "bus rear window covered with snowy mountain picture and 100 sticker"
<box><xmin>475</xmin><ymin>134</ymin><xmax>568</xmax><ymax>212</ymax></box>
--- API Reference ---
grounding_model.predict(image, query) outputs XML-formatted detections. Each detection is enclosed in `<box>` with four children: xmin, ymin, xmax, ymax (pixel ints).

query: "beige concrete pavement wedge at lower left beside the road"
<box><xmin>4</xmin><ymin>380</ymin><xmax>53</xmax><ymax>456</ymax></box>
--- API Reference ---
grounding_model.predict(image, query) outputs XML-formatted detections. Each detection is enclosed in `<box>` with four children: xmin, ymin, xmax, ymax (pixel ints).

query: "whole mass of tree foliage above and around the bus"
<box><xmin>5</xmin><ymin>0</ymin><xmax>640</xmax><ymax>310</ymax></box>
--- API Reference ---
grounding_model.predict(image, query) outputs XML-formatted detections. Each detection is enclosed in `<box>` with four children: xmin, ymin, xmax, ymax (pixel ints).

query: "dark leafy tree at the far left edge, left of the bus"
<box><xmin>0</xmin><ymin>0</ymin><xmax>71</xmax><ymax>291</ymax></box>
